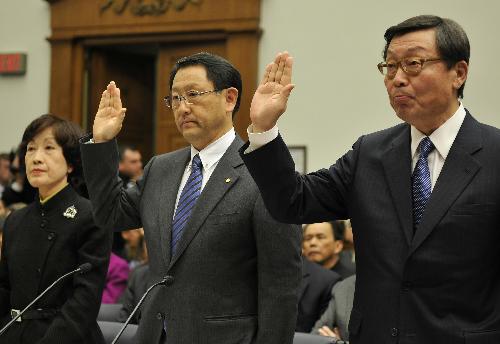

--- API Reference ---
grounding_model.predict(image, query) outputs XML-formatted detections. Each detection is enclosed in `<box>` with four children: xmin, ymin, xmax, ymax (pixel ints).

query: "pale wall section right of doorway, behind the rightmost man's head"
<box><xmin>259</xmin><ymin>0</ymin><xmax>500</xmax><ymax>171</ymax></box>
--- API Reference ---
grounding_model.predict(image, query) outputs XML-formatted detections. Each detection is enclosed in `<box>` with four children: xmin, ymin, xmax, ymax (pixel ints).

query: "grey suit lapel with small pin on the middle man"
<box><xmin>169</xmin><ymin>137</ymin><xmax>243</xmax><ymax>268</ymax></box>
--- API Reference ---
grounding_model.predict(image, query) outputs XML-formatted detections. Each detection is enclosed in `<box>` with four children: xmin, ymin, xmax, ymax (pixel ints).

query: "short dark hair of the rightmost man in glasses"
<box><xmin>383</xmin><ymin>15</ymin><xmax>470</xmax><ymax>98</ymax></box>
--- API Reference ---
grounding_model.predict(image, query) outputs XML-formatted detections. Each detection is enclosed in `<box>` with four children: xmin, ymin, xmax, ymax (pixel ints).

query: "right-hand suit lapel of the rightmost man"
<box><xmin>409</xmin><ymin>112</ymin><xmax>482</xmax><ymax>254</ymax></box>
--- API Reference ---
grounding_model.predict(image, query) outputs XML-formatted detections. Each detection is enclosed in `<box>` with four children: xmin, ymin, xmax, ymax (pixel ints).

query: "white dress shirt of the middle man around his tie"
<box><xmin>174</xmin><ymin>127</ymin><xmax>236</xmax><ymax>211</ymax></box>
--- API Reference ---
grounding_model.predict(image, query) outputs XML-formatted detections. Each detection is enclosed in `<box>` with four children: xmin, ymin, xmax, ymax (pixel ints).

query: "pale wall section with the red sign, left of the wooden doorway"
<box><xmin>0</xmin><ymin>0</ymin><xmax>50</xmax><ymax>152</ymax></box>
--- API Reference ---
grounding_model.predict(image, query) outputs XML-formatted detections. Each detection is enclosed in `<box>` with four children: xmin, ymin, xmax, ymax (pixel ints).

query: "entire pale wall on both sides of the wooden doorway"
<box><xmin>0</xmin><ymin>0</ymin><xmax>500</xmax><ymax>171</ymax></box>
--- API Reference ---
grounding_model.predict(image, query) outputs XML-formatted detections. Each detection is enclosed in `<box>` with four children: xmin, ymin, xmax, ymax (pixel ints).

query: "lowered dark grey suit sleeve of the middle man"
<box><xmin>253</xmin><ymin>197</ymin><xmax>302</xmax><ymax>344</ymax></box>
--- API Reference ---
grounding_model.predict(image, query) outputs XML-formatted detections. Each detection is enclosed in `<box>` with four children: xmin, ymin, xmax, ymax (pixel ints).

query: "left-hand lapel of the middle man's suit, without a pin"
<box><xmin>158</xmin><ymin>147</ymin><xmax>191</xmax><ymax>266</ymax></box>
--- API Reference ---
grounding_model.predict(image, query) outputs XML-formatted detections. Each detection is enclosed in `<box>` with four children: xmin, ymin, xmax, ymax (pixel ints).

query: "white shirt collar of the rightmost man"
<box><xmin>411</xmin><ymin>102</ymin><xmax>466</xmax><ymax>160</ymax></box>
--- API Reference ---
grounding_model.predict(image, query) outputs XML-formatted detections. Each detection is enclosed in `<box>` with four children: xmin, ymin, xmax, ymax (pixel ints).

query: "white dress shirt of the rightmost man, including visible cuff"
<box><xmin>245</xmin><ymin>102</ymin><xmax>465</xmax><ymax>189</ymax></box>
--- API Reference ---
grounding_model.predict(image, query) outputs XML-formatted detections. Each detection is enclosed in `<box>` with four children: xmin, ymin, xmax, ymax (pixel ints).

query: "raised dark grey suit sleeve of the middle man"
<box><xmin>80</xmin><ymin>139</ymin><xmax>153</xmax><ymax>231</ymax></box>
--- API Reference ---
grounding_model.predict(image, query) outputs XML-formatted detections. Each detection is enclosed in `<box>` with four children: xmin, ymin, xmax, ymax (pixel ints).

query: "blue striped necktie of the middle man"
<box><xmin>171</xmin><ymin>154</ymin><xmax>203</xmax><ymax>256</ymax></box>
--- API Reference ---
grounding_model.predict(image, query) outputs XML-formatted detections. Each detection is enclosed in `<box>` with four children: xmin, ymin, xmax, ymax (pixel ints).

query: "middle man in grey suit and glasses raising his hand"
<box><xmin>81</xmin><ymin>53</ymin><xmax>302</xmax><ymax>344</ymax></box>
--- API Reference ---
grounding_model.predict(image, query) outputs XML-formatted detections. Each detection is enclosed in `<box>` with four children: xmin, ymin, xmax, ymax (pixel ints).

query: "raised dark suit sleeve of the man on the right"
<box><xmin>240</xmin><ymin>136</ymin><xmax>362</xmax><ymax>224</ymax></box>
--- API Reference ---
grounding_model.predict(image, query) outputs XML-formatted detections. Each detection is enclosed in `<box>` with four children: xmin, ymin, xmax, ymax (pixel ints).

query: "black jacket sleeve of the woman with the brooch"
<box><xmin>39</xmin><ymin>210</ymin><xmax>112</xmax><ymax>344</ymax></box>
